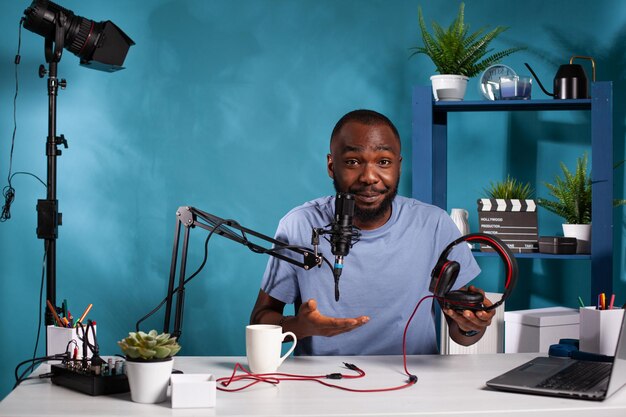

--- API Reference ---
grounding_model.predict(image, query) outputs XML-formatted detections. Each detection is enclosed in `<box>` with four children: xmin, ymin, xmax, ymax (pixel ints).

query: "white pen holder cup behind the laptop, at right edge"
<box><xmin>580</xmin><ymin>307</ymin><xmax>624</xmax><ymax>356</ymax></box>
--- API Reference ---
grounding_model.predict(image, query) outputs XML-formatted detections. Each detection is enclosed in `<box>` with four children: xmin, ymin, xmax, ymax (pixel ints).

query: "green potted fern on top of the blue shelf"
<box><xmin>411</xmin><ymin>3</ymin><xmax>523</xmax><ymax>101</ymax></box>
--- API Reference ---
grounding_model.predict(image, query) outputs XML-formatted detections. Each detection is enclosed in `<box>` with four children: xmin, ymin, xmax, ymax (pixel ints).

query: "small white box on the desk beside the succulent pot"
<box><xmin>170</xmin><ymin>374</ymin><xmax>216</xmax><ymax>408</ymax></box>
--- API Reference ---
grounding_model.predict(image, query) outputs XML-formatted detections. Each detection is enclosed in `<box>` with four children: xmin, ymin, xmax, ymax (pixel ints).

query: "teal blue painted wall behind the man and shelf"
<box><xmin>0</xmin><ymin>0</ymin><xmax>626</xmax><ymax>398</ymax></box>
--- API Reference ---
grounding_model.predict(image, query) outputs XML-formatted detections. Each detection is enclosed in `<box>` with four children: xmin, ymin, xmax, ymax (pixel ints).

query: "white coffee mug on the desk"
<box><xmin>246</xmin><ymin>324</ymin><xmax>297</xmax><ymax>374</ymax></box>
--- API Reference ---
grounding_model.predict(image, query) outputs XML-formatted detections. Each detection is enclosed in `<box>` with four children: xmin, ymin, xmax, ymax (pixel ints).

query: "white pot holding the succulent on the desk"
<box><xmin>125</xmin><ymin>358</ymin><xmax>174</xmax><ymax>404</ymax></box>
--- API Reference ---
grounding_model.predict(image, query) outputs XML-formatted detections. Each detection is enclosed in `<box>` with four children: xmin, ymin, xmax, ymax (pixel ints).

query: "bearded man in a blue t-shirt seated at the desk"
<box><xmin>250</xmin><ymin>110</ymin><xmax>495</xmax><ymax>355</ymax></box>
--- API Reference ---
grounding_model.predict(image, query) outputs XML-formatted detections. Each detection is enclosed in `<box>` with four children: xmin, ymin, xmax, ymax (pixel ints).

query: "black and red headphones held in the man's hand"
<box><xmin>428</xmin><ymin>233</ymin><xmax>518</xmax><ymax>311</ymax></box>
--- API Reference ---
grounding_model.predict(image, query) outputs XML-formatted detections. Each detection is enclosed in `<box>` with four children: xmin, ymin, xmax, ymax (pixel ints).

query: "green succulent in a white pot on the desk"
<box><xmin>117</xmin><ymin>330</ymin><xmax>180</xmax><ymax>404</ymax></box>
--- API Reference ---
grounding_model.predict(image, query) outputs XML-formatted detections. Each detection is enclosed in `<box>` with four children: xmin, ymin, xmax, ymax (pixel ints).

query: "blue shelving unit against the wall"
<box><xmin>412</xmin><ymin>81</ymin><xmax>613</xmax><ymax>305</ymax></box>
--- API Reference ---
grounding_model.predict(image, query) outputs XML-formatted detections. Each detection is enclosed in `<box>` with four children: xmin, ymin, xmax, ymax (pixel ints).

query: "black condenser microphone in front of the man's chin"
<box><xmin>330</xmin><ymin>193</ymin><xmax>358</xmax><ymax>301</ymax></box>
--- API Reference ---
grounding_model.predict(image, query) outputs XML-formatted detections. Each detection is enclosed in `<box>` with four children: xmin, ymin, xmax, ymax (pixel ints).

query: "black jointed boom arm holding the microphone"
<box><xmin>163</xmin><ymin>206</ymin><xmax>332</xmax><ymax>338</ymax></box>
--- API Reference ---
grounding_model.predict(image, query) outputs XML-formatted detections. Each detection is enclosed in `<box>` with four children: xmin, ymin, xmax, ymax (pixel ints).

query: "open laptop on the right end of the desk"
<box><xmin>487</xmin><ymin>314</ymin><xmax>626</xmax><ymax>401</ymax></box>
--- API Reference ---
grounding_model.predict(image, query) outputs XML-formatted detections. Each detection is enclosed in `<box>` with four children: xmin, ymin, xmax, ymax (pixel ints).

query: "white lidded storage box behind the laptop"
<box><xmin>504</xmin><ymin>307</ymin><xmax>579</xmax><ymax>353</ymax></box>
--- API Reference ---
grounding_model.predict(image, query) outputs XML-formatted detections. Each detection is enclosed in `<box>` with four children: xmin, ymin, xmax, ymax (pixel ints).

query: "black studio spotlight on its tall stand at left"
<box><xmin>21</xmin><ymin>0</ymin><xmax>135</xmax><ymax>325</ymax></box>
